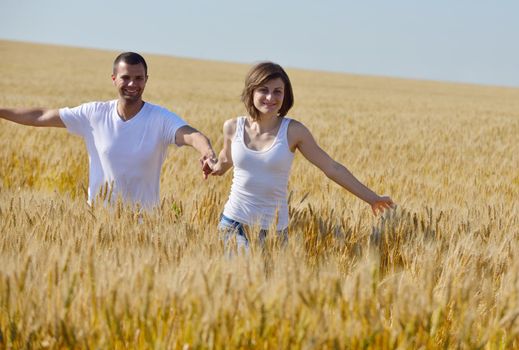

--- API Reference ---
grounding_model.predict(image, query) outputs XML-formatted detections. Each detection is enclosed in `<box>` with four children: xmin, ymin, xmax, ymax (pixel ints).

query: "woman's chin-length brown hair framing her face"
<box><xmin>241</xmin><ymin>62</ymin><xmax>294</xmax><ymax>120</ymax></box>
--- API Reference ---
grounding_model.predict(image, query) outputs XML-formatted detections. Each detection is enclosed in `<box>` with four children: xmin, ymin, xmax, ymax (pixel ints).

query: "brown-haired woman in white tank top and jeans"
<box><xmin>204</xmin><ymin>62</ymin><xmax>394</xmax><ymax>249</ymax></box>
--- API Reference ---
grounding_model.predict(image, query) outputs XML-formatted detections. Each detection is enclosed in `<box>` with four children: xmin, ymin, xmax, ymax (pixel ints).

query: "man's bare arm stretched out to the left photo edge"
<box><xmin>0</xmin><ymin>108</ymin><xmax>65</xmax><ymax>128</ymax></box>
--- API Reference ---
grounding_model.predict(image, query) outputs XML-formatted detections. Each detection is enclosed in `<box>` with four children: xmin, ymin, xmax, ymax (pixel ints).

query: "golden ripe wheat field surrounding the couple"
<box><xmin>0</xmin><ymin>41</ymin><xmax>519</xmax><ymax>349</ymax></box>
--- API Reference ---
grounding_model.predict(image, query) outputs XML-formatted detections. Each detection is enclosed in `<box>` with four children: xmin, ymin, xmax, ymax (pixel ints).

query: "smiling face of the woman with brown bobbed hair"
<box><xmin>253</xmin><ymin>78</ymin><xmax>285</xmax><ymax>116</ymax></box>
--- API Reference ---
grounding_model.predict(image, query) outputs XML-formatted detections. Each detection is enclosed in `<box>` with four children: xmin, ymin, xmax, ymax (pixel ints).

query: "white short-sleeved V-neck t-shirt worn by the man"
<box><xmin>59</xmin><ymin>100</ymin><xmax>187</xmax><ymax>208</ymax></box>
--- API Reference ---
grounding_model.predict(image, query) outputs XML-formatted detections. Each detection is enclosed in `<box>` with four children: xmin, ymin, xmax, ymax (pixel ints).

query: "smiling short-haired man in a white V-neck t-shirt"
<box><xmin>0</xmin><ymin>52</ymin><xmax>216</xmax><ymax>209</ymax></box>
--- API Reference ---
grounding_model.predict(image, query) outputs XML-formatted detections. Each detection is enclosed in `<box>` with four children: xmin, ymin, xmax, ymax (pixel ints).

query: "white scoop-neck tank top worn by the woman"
<box><xmin>223</xmin><ymin>117</ymin><xmax>294</xmax><ymax>230</ymax></box>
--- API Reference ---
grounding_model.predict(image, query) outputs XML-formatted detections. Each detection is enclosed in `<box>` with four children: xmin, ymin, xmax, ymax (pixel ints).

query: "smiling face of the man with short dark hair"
<box><xmin>112</xmin><ymin>61</ymin><xmax>148</xmax><ymax>102</ymax></box>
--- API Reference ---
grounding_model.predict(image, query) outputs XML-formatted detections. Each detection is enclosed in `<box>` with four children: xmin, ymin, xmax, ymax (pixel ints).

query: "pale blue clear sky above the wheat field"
<box><xmin>0</xmin><ymin>0</ymin><xmax>519</xmax><ymax>87</ymax></box>
